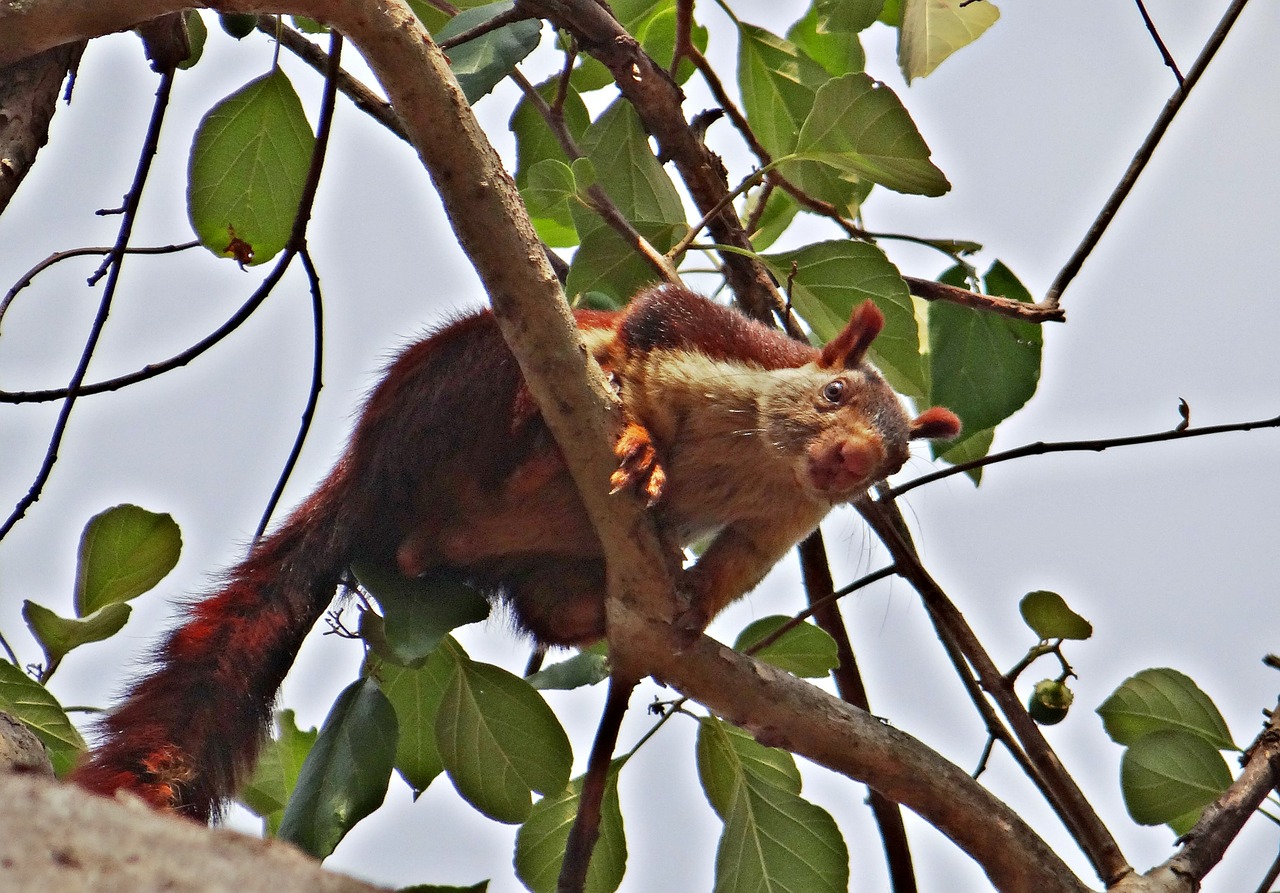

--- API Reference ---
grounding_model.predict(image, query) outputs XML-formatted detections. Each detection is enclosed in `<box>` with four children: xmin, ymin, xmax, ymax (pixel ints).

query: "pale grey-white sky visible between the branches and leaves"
<box><xmin>0</xmin><ymin>0</ymin><xmax>1280</xmax><ymax>893</ymax></box>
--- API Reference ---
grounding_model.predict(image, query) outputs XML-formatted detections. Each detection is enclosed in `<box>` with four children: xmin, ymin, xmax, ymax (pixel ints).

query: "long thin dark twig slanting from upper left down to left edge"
<box><xmin>0</xmin><ymin>70</ymin><xmax>173</xmax><ymax>540</ymax></box>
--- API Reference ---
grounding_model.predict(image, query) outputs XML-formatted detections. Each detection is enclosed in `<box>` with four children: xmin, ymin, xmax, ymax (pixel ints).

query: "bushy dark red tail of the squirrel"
<box><xmin>73</xmin><ymin>473</ymin><xmax>349</xmax><ymax>821</ymax></box>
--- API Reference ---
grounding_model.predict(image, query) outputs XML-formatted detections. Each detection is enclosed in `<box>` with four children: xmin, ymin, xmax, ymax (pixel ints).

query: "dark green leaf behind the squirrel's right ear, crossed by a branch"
<box><xmin>928</xmin><ymin>261</ymin><xmax>1043</xmax><ymax>431</ymax></box>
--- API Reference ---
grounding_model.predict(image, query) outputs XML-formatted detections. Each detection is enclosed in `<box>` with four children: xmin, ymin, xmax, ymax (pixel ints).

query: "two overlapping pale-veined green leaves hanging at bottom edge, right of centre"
<box><xmin>698</xmin><ymin>718</ymin><xmax>849</xmax><ymax>893</ymax></box>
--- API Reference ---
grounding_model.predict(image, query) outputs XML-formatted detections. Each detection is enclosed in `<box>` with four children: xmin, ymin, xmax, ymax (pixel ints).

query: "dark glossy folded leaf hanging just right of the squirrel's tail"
<box><xmin>279</xmin><ymin>678</ymin><xmax>398</xmax><ymax>858</ymax></box>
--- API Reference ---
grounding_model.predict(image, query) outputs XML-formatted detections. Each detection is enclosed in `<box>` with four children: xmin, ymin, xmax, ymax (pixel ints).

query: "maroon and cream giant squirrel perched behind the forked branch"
<box><xmin>67</xmin><ymin>287</ymin><xmax>957</xmax><ymax>820</ymax></box>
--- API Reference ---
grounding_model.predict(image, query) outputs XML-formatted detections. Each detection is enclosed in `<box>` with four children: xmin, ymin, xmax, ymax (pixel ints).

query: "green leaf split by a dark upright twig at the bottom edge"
<box><xmin>516</xmin><ymin>760</ymin><xmax>627</xmax><ymax>893</ymax></box>
